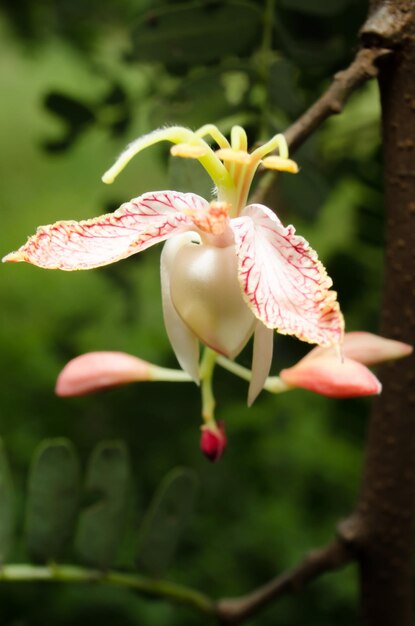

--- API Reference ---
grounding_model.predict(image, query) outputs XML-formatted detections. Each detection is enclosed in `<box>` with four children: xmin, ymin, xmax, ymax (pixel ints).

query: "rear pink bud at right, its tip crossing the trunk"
<box><xmin>304</xmin><ymin>331</ymin><xmax>413</xmax><ymax>365</ymax></box>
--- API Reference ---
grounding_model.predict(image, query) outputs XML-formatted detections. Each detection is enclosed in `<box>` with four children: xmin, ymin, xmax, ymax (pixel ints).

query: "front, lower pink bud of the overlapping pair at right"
<box><xmin>280</xmin><ymin>354</ymin><xmax>382</xmax><ymax>398</ymax></box>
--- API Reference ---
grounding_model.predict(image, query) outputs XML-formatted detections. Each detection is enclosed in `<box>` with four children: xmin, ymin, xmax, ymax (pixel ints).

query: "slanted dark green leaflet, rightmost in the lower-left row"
<box><xmin>137</xmin><ymin>468</ymin><xmax>198</xmax><ymax>576</ymax></box>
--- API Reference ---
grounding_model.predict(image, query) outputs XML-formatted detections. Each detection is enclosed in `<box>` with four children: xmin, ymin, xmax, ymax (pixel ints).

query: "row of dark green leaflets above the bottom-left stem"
<box><xmin>0</xmin><ymin>438</ymin><xmax>198</xmax><ymax>577</ymax></box>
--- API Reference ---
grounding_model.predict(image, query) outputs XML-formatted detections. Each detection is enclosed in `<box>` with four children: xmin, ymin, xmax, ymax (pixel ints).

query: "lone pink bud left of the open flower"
<box><xmin>55</xmin><ymin>352</ymin><xmax>151</xmax><ymax>397</ymax></box>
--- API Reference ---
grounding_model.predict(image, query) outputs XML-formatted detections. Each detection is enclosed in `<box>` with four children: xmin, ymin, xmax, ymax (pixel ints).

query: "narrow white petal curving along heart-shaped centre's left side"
<box><xmin>160</xmin><ymin>232</ymin><xmax>199</xmax><ymax>384</ymax></box>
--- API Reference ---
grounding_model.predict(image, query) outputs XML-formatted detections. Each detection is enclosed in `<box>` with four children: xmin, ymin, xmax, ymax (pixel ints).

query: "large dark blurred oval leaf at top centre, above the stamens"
<box><xmin>132</xmin><ymin>0</ymin><xmax>262</xmax><ymax>67</ymax></box>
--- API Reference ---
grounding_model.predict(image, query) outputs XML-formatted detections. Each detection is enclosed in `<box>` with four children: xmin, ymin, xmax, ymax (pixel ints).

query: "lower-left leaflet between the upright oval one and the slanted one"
<box><xmin>75</xmin><ymin>441</ymin><xmax>130</xmax><ymax>569</ymax></box>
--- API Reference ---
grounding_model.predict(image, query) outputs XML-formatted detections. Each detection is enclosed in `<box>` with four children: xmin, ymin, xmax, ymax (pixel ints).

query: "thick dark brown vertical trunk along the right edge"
<box><xmin>356</xmin><ymin>0</ymin><xmax>415</xmax><ymax>626</ymax></box>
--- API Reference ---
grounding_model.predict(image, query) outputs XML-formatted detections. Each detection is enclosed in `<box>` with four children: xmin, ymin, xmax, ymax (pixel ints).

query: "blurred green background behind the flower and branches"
<box><xmin>0</xmin><ymin>0</ymin><xmax>383</xmax><ymax>626</ymax></box>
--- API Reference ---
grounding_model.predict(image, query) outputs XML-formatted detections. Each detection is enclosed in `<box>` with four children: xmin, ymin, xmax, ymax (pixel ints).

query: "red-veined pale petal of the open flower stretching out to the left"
<box><xmin>3</xmin><ymin>191</ymin><xmax>209</xmax><ymax>271</ymax></box>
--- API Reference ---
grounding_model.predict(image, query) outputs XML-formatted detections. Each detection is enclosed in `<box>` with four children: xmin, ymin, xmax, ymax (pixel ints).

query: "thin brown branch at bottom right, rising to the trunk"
<box><xmin>216</xmin><ymin>539</ymin><xmax>354</xmax><ymax>625</ymax></box>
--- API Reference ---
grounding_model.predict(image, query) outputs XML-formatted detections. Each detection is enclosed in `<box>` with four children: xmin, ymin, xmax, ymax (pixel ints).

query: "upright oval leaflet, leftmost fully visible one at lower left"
<box><xmin>26</xmin><ymin>439</ymin><xmax>80</xmax><ymax>561</ymax></box>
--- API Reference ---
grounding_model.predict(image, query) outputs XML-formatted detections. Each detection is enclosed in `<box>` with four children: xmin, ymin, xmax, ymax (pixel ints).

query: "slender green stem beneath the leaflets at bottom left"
<box><xmin>0</xmin><ymin>563</ymin><xmax>215</xmax><ymax>615</ymax></box>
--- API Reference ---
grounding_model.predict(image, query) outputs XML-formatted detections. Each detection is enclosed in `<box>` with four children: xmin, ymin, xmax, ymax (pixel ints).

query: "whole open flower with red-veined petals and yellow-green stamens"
<box><xmin>3</xmin><ymin>125</ymin><xmax>344</xmax><ymax>410</ymax></box>
